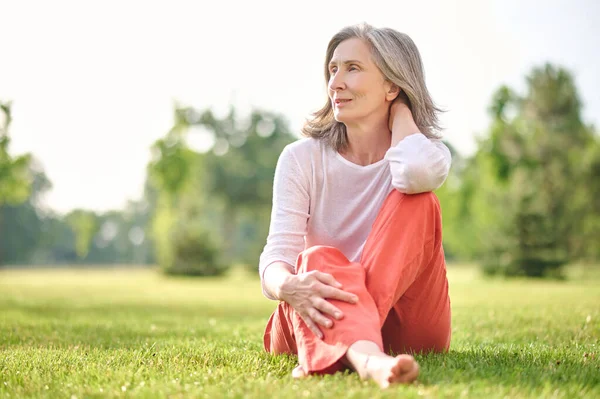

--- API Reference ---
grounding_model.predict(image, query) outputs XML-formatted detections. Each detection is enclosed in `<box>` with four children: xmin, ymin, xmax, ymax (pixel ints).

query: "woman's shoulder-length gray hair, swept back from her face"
<box><xmin>302</xmin><ymin>24</ymin><xmax>443</xmax><ymax>151</ymax></box>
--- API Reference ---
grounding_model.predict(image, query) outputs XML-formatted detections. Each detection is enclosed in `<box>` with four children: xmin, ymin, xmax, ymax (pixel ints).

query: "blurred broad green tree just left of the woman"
<box><xmin>149</xmin><ymin>107</ymin><xmax>294</xmax><ymax>274</ymax></box>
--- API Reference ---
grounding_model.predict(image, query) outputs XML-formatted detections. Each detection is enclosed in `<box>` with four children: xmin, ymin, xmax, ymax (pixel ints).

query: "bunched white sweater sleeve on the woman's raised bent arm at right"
<box><xmin>385</xmin><ymin>133</ymin><xmax>452</xmax><ymax>194</ymax></box>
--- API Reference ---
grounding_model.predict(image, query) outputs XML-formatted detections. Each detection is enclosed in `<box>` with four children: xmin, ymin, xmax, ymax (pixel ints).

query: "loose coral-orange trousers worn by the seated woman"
<box><xmin>264</xmin><ymin>190</ymin><xmax>451</xmax><ymax>374</ymax></box>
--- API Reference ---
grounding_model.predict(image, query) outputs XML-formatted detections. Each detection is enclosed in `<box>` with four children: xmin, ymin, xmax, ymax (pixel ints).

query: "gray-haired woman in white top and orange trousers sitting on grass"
<box><xmin>259</xmin><ymin>24</ymin><xmax>451</xmax><ymax>388</ymax></box>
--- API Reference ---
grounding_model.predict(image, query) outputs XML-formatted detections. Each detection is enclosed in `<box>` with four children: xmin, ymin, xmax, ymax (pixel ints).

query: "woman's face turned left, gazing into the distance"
<box><xmin>328</xmin><ymin>38</ymin><xmax>397</xmax><ymax>125</ymax></box>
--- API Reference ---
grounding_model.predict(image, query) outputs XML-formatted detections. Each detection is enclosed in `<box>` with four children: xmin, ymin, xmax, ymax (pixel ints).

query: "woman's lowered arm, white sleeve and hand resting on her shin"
<box><xmin>259</xmin><ymin>143</ymin><xmax>358</xmax><ymax>337</ymax></box>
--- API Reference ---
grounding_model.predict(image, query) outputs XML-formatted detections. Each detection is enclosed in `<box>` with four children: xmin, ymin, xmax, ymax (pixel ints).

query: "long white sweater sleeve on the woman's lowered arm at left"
<box><xmin>259</xmin><ymin>146</ymin><xmax>310</xmax><ymax>299</ymax></box>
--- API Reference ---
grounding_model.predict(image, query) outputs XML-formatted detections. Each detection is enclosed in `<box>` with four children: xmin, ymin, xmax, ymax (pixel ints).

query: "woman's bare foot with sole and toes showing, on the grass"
<box><xmin>366</xmin><ymin>355</ymin><xmax>419</xmax><ymax>388</ymax></box>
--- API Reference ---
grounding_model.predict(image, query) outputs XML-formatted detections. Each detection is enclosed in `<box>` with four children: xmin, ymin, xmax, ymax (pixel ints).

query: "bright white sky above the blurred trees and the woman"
<box><xmin>0</xmin><ymin>0</ymin><xmax>600</xmax><ymax>212</ymax></box>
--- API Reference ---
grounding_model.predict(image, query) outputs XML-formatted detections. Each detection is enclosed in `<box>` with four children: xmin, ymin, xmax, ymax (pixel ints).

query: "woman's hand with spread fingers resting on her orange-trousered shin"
<box><xmin>279</xmin><ymin>270</ymin><xmax>358</xmax><ymax>338</ymax></box>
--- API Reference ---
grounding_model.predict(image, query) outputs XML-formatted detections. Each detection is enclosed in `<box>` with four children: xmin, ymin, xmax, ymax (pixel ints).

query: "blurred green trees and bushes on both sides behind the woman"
<box><xmin>0</xmin><ymin>64</ymin><xmax>600</xmax><ymax>277</ymax></box>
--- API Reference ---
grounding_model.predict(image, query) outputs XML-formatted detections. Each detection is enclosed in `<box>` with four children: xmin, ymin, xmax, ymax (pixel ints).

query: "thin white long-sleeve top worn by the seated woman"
<box><xmin>259</xmin><ymin>133</ymin><xmax>451</xmax><ymax>299</ymax></box>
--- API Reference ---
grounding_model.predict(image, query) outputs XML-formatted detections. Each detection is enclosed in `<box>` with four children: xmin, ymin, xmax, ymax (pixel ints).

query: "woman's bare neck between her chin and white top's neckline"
<box><xmin>340</xmin><ymin>120</ymin><xmax>391</xmax><ymax>166</ymax></box>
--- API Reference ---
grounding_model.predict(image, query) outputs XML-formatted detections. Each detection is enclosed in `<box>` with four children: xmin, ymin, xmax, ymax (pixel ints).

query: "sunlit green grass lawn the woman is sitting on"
<box><xmin>0</xmin><ymin>267</ymin><xmax>600</xmax><ymax>399</ymax></box>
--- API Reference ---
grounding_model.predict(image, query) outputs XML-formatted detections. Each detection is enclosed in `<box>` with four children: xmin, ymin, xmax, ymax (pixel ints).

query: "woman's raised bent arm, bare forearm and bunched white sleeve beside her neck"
<box><xmin>385</xmin><ymin>102</ymin><xmax>452</xmax><ymax>194</ymax></box>
